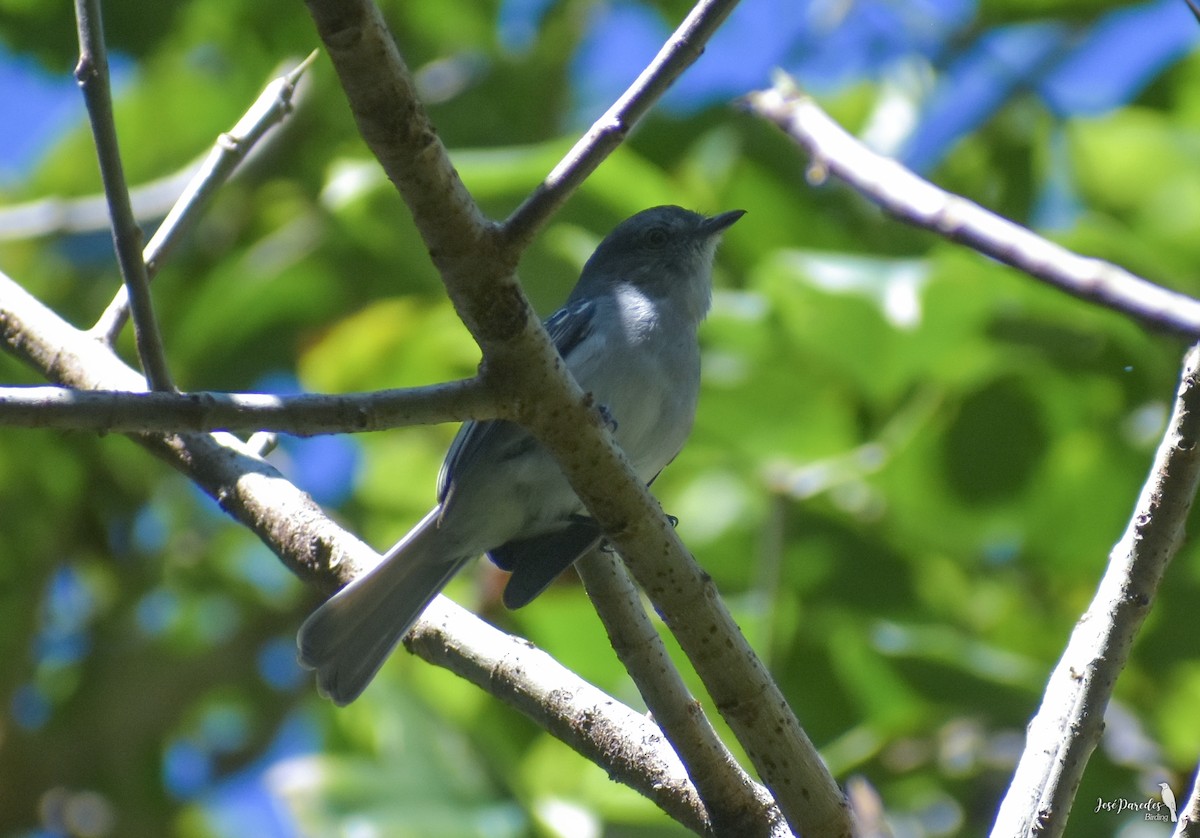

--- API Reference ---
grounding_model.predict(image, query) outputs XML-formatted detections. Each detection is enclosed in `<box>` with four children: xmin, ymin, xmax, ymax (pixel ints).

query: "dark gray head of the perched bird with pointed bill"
<box><xmin>571</xmin><ymin>206</ymin><xmax>745</xmax><ymax>322</ymax></box>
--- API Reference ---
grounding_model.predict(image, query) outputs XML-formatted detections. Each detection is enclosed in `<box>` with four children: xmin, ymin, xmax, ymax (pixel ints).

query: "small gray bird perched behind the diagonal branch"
<box><xmin>296</xmin><ymin>205</ymin><xmax>744</xmax><ymax>706</ymax></box>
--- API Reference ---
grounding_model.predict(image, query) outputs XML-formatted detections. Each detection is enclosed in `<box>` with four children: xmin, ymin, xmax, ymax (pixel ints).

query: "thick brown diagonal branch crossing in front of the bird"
<box><xmin>307</xmin><ymin>0</ymin><xmax>851</xmax><ymax>836</ymax></box>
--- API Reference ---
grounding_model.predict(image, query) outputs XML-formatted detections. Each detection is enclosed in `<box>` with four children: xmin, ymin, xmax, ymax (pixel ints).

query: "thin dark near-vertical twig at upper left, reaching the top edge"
<box><xmin>76</xmin><ymin>0</ymin><xmax>175</xmax><ymax>390</ymax></box>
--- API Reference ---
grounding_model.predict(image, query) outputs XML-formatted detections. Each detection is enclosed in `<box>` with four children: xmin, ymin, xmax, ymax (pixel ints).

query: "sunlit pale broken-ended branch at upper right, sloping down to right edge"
<box><xmin>748</xmin><ymin>80</ymin><xmax>1200</xmax><ymax>340</ymax></box>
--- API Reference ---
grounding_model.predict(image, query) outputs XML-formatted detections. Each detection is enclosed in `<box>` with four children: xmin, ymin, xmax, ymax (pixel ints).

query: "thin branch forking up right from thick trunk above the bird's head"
<box><xmin>504</xmin><ymin>0</ymin><xmax>738</xmax><ymax>246</ymax></box>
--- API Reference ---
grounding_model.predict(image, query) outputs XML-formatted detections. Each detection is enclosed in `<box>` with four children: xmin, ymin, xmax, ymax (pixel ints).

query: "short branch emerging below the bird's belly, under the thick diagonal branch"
<box><xmin>575</xmin><ymin>550</ymin><xmax>791</xmax><ymax>838</ymax></box>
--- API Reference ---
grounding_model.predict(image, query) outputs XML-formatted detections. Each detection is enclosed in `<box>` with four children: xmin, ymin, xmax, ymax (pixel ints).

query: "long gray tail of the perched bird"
<box><xmin>296</xmin><ymin>508</ymin><xmax>472</xmax><ymax>705</ymax></box>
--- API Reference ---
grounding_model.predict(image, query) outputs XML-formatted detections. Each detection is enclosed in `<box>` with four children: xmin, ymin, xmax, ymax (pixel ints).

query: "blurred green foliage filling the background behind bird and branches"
<box><xmin>0</xmin><ymin>0</ymin><xmax>1200</xmax><ymax>837</ymax></box>
